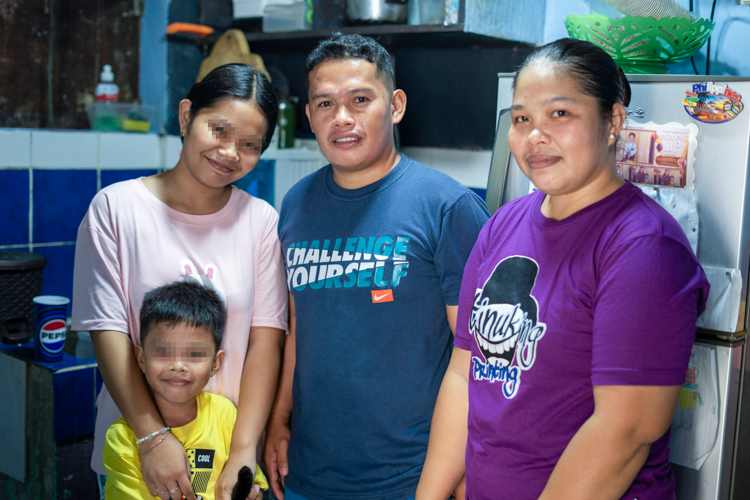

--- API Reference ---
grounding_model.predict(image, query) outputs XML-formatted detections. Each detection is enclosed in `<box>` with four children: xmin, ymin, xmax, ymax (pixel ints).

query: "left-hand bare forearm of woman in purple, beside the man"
<box><xmin>417</xmin><ymin>347</ymin><xmax>471</xmax><ymax>500</ymax></box>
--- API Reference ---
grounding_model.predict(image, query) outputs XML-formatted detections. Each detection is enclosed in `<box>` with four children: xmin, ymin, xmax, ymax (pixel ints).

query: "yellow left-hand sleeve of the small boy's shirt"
<box><xmin>104</xmin><ymin>422</ymin><xmax>158</xmax><ymax>500</ymax></box>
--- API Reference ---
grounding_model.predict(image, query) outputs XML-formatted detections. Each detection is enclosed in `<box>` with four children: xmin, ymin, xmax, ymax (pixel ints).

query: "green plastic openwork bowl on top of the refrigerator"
<box><xmin>565</xmin><ymin>14</ymin><xmax>715</xmax><ymax>73</ymax></box>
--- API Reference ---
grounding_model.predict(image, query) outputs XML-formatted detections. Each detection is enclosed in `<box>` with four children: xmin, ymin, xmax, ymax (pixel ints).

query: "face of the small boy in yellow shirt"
<box><xmin>135</xmin><ymin>323</ymin><xmax>224</xmax><ymax>404</ymax></box>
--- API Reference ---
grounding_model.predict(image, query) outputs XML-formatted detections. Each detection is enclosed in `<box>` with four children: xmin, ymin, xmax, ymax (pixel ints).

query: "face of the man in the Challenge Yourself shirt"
<box><xmin>305</xmin><ymin>58</ymin><xmax>406</xmax><ymax>171</ymax></box>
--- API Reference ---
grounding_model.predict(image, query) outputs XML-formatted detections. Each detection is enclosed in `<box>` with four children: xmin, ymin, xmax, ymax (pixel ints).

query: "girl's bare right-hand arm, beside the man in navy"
<box><xmin>215</xmin><ymin>326</ymin><xmax>284</xmax><ymax>500</ymax></box>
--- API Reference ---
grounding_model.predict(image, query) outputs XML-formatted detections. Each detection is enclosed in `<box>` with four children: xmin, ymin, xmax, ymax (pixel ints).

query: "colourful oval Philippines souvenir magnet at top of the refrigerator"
<box><xmin>682</xmin><ymin>82</ymin><xmax>744</xmax><ymax>123</ymax></box>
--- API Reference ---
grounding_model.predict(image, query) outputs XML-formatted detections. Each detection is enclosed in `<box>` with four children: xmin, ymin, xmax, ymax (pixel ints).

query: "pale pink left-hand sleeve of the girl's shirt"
<box><xmin>72</xmin><ymin>193</ymin><xmax>128</xmax><ymax>332</ymax></box>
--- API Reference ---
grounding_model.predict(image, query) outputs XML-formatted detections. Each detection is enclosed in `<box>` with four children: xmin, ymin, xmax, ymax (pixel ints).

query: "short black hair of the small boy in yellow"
<box><xmin>140</xmin><ymin>281</ymin><xmax>227</xmax><ymax>351</ymax></box>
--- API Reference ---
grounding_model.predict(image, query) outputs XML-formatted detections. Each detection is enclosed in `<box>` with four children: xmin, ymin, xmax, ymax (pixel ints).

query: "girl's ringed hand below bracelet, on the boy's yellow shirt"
<box><xmin>140</xmin><ymin>434</ymin><xmax>197</xmax><ymax>500</ymax></box>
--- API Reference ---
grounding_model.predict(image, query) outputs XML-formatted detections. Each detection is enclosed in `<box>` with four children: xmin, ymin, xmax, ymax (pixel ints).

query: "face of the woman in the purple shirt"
<box><xmin>508</xmin><ymin>61</ymin><xmax>621</xmax><ymax>196</ymax></box>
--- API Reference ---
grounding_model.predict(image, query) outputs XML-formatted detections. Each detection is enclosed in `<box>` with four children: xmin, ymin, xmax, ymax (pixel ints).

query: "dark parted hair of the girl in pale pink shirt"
<box><xmin>186</xmin><ymin>63</ymin><xmax>279</xmax><ymax>152</ymax></box>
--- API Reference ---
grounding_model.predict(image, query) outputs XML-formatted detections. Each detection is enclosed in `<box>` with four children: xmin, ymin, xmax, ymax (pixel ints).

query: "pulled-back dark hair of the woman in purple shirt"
<box><xmin>513</xmin><ymin>38</ymin><xmax>630</xmax><ymax>119</ymax></box>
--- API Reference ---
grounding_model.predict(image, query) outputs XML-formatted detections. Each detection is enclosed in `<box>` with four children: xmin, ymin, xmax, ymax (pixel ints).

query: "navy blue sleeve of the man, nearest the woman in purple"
<box><xmin>435</xmin><ymin>191</ymin><xmax>490</xmax><ymax>306</ymax></box>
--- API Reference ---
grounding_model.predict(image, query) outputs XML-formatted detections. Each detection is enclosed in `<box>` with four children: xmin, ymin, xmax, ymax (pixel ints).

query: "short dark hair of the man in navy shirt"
<box><xmin>305</xmin><ymin>32</ymin><xmax>396</xmax><ymax>92</ymax></box>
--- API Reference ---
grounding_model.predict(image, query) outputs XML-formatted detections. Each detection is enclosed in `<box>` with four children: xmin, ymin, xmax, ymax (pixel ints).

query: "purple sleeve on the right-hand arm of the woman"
<box><xmin>591</xmin><ymin>235</ymin><xmax>708</xmax><ymax>386</ymax></box>
